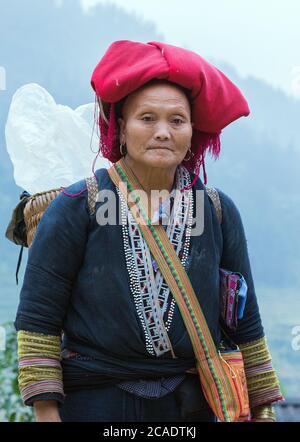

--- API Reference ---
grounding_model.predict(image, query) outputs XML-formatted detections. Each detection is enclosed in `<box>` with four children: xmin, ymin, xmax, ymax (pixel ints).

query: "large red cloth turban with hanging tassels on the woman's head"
<box><xmin>91</xmin><ymin>40</ymin><xmax>250</xmax><ymax>184</ymax></box>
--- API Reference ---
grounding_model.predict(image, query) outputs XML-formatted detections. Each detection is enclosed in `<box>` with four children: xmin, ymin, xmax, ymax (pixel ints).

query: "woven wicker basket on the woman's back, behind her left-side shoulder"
<box><xmin>24</xmin><ymin>188</ymin><xmax>61</xmax><ymax>247</ymax></box>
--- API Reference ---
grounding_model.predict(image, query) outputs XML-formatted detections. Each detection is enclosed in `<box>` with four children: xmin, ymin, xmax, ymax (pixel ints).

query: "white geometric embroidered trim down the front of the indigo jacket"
<box><xmin>116</xmin><ymin>166</ymin><xmax>193</xmax><ymax>356</ymax></box>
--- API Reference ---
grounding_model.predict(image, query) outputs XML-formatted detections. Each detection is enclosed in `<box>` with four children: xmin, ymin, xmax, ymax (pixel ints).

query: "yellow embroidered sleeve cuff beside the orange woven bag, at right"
<box><xmin>239</xmin><ymin>336</ymin><xmax>284</xmax><ymax>409</ymax></box>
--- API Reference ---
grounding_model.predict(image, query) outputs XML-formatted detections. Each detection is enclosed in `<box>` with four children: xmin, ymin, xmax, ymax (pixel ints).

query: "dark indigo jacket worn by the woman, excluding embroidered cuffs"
<box><xmin>14</xmin><ymin>169</ymin><xmax>264</xmax><ymax>394</ymax></box>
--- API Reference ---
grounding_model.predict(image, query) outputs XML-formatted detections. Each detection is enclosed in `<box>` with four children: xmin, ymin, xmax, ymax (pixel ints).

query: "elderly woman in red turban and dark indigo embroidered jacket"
<box><xmin>15</xmin><ymin>41</ymin><xmax>282</xmax><ymax>422</ymax></box>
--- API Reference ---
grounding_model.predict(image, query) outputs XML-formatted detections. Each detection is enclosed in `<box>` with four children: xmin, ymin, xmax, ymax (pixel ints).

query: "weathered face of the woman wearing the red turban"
<box><xmin>118</xmin><ymin>83</ymin><xmax>193</xmax><ymax>168</ymax></box>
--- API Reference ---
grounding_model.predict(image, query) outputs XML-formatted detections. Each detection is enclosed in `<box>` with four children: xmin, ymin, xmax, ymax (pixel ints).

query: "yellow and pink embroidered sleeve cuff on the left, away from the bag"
<box><xmin>18</xmin><ymin>330</ymin><xmax>65</xmax><ymax>405</ymax></box>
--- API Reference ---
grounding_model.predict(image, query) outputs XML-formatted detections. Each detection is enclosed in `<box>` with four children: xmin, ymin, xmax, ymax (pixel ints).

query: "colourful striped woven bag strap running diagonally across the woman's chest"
<box><xmin>108</xmin><ymin>159</ymin><xmax>238</xmax><ymax>422</ymax></box>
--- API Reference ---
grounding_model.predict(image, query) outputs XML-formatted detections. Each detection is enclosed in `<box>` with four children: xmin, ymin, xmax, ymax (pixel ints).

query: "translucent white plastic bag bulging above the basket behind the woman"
<box><xmin>5</xmin><ymin>83</ymin><xmax>110</xmax><ymax>194</ymax></box>
